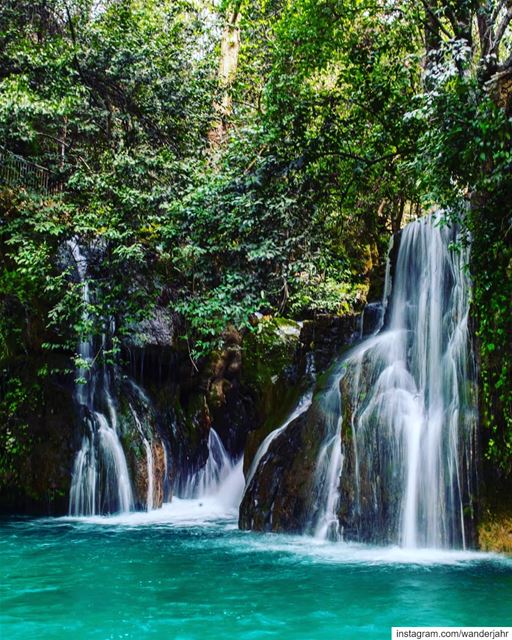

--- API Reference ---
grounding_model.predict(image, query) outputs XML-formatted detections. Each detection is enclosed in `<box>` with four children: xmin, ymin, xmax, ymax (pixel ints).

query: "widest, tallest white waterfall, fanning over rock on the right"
<box><xmin>309</xmin><ymin>215</ymin><xmax>476</xmax><ymax>547</ymax></box>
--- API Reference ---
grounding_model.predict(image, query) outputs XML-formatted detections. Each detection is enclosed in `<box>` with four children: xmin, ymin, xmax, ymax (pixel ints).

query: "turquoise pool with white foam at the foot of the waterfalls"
<box><xmin>0</xmin><ymin>504</ymin><xmax>512</xmax><ymax>640</ymax></box>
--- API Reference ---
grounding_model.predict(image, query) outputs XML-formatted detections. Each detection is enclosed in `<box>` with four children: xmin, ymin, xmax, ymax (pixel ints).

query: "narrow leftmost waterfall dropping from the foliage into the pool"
<box><xmin>68</xmin><ymin>240</ymin><xmax>134</xmax><ymax>516</ymax></box>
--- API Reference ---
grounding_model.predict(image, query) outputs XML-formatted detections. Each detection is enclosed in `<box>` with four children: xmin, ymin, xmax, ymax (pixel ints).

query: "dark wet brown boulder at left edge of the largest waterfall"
<box><xmin>239</xmin><ymin>316</ymin><xmax>360</xmax><ymax>533</ymax></box>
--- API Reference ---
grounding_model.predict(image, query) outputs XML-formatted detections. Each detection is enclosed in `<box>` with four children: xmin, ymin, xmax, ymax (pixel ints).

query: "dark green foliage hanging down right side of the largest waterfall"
<box><xmin>411</xmin><ymin>45</ymin><xmax>512</xmax><ymax>475</ymax></box>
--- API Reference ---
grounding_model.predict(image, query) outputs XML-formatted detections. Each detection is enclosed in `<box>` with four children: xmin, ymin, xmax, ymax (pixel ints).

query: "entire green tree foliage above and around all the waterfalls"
<box><xmin>0</xmin><ymin>0</ymin><xmax>512</xmax><ymax>478</ymax></box>
